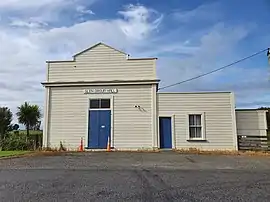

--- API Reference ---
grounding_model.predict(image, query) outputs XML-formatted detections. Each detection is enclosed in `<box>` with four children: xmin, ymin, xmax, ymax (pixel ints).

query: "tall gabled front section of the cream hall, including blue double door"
<box><xmin>43</xmin><ymin>43</ymin><xmax>158</xmax><ymax>149</ymax></box>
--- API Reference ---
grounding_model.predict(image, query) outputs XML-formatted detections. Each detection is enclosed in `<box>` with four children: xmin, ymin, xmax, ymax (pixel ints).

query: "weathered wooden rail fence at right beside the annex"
<box><xmin>238</xmin><ymin>135</ymin><xmax>270</xmax><ymax>151</ymax></box>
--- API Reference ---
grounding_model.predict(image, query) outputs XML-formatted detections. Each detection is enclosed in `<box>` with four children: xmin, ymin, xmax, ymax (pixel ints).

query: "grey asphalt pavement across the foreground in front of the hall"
<box><xmin>0</xmin><ymin>152</ymin><xmax>270</xmax><ymax>202</ymax></box>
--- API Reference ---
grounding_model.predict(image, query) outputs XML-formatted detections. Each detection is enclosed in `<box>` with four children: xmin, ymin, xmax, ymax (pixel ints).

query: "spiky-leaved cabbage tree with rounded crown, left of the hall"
<box><xmin>16</xmin><ymin>102</ymin><xmax>41</xmax><ymax>137</ymax></box>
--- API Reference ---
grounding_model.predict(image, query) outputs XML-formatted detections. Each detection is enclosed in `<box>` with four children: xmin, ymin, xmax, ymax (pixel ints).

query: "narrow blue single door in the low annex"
<box><xmin>159</xmin><ymin>117</ymin><xmax>172</xmax><ymax>149</ymax></box>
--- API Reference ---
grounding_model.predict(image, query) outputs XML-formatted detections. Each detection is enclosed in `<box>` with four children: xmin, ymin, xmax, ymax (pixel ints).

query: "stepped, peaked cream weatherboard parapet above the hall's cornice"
<box><xmin>47</xmin><ymin>44</ymin><xmax>156</xmax><ymax>82</ymax></box>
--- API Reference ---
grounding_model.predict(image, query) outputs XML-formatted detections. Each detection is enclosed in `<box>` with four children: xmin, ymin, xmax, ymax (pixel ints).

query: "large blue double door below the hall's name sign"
<box><xmin>88</xmin><ymin>110</ymin><xmax>111</xmax><ymax>149</ymax></box>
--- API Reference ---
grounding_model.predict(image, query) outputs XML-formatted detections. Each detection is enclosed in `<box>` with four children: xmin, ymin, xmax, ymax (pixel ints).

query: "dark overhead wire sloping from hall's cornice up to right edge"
<box><xmin>158</xmin><ymin>48</ymin><xmax>269</xmax><ymax>90</ymax></box>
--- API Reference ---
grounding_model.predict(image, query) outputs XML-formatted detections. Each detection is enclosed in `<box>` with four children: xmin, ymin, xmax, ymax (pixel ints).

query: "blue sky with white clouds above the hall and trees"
<box><xmin>0</xmin><ymin>0</ymin><xmax>270</xmax><ymax>122</ymax></box>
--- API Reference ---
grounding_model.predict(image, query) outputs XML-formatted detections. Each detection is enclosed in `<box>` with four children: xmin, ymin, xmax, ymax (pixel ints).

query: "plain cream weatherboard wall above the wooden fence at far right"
<box><xmin>236</xmin><ymin>110</ymin><xmax>267</xmax><ymax>136</ymax></box>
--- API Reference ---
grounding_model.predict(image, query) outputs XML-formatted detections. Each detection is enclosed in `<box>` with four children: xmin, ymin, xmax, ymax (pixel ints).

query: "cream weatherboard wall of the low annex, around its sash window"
<box><xmin>157</xmin><ymin>92</ymin><xmax>237</xmax><ymax>150</ymax></box>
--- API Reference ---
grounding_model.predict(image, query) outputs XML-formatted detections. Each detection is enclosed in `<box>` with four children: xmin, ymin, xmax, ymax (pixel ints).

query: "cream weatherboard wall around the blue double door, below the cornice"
<box><xmin>45</xmin><ymin>85</ymin><xmax>156</xmax><ymax>149</ymax></box>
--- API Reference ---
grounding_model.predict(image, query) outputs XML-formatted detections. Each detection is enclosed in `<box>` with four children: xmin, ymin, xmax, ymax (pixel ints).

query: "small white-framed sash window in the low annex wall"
<box><xmin>189</xmin><ymin>114</ymin><xmax>203</xmax><ymax>139</ymax></box>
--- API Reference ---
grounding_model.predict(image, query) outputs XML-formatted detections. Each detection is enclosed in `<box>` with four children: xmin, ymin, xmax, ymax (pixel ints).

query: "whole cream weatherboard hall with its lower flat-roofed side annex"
<box><xmin>42</xmin><ymin>43</ymin><xmax>243</xmax><ymax>150</ymax></box>
